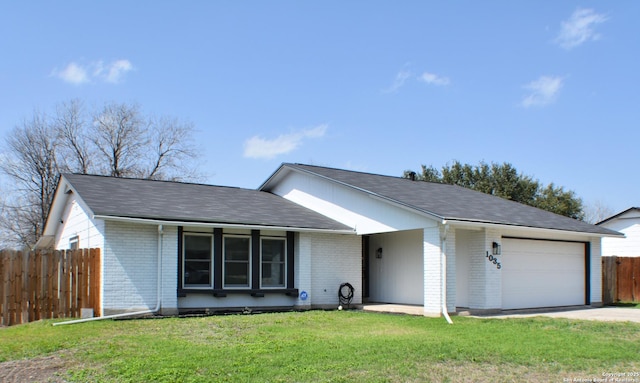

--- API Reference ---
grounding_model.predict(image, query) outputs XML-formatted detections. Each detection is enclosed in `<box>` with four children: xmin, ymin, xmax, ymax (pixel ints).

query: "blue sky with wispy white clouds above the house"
<box><xmin>0</xmin><ymin>0</ymin><xmax>640</xmax><ymax>212</ymax></box>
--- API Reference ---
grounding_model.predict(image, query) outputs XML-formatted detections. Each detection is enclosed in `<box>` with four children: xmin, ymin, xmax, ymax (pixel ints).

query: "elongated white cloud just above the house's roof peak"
<box><xmin>244</xmin><ymin>124</ymin><xmax>328</xmax><ymax>159</ymax></box>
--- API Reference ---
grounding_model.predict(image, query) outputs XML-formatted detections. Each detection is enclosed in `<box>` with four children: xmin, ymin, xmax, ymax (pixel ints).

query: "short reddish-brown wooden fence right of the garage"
<box><xmin>602</xmin><ymin>256</ymin><xmax>640</xmax><ymax>304</ymax></box>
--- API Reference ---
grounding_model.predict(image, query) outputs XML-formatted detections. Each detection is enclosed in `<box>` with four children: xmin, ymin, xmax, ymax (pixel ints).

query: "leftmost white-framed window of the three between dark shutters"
<box><xmin>183</xmin><ymin>234</ymin><xmax>213</xmax><ymax>287</ymax></box>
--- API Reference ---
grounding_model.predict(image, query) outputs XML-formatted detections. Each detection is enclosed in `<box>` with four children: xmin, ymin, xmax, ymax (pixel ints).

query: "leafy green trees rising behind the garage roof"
<box><xmin>404</xmin><ymin>161</ymin><xmax>584</xmax><ymax>220</ymax></box>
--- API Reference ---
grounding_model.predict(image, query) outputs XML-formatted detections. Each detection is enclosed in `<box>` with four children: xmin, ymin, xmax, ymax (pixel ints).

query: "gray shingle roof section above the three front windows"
<box><xmin>63</xmin><ymin>174</ymin><xmax>352</xmax><ymax>231</ymax></box>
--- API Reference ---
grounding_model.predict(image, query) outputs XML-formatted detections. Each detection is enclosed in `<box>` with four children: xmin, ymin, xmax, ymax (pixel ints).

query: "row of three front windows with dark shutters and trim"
<box><xmin>177</xmin><ymin>226</ymin><xmax>297</xmax><ymax>298</ymax></box>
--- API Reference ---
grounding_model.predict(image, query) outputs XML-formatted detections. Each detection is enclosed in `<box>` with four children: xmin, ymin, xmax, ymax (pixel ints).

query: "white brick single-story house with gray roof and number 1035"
<box><xmin>38</xmin><ymin>163</ymin><xmax>620</xmax><ymax>316</ymax></box>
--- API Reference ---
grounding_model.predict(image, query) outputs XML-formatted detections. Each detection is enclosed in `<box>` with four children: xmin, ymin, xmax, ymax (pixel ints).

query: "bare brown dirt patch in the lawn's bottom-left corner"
<box><xmin>0</xmin><ymin>355</ymin><xmax>69</xmax><ymax>383</ymax></box>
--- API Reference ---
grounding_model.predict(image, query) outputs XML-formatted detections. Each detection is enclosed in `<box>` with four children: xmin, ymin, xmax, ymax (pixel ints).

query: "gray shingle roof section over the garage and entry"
<box><xmin>274</xmin><ymin>164</ymin><xmax>620</xmax><ymax>235</ymax></box>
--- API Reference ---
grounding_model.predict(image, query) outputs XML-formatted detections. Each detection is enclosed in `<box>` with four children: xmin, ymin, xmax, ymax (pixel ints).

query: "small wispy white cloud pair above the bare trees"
<box><xmin>52</xmin><ymin>60</ymin><xmax>133</xmax><ymax>85</ymax></box>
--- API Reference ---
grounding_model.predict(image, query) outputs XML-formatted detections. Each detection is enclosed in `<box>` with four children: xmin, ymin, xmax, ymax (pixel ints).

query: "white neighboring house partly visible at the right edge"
<box><xmin>596</xmin><ymin>207</ymin><xmax>640</xmax><ymax>257</ymax></box>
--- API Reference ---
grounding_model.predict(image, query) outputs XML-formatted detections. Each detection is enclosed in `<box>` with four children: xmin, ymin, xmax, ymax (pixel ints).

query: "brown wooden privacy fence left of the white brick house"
<box><xmin>0</xmin><ymin>249</ymin><xmax>100</xmax><ymax>326</ymax></box>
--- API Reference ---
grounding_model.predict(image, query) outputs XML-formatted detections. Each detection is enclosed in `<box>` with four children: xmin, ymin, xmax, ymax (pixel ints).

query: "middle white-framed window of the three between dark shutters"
<box><xmin>223</xmin><ymin>236</ymin><xmax>251</xmax><ymax>287</ymax></box>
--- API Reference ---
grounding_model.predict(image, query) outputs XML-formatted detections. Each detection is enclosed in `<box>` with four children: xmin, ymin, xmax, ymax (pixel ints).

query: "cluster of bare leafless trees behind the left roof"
<box><xmin>0</xmin><ymin>100</ymin><xmax>198</xmax><ymax>246</ymax></box>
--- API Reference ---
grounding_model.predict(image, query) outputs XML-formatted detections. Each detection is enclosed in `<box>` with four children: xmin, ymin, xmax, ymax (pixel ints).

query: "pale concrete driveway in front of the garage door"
<box><xmin>478</xmin><ymin>307</ymin><xmax>640</xmax><ymax>323</ymax></box>
